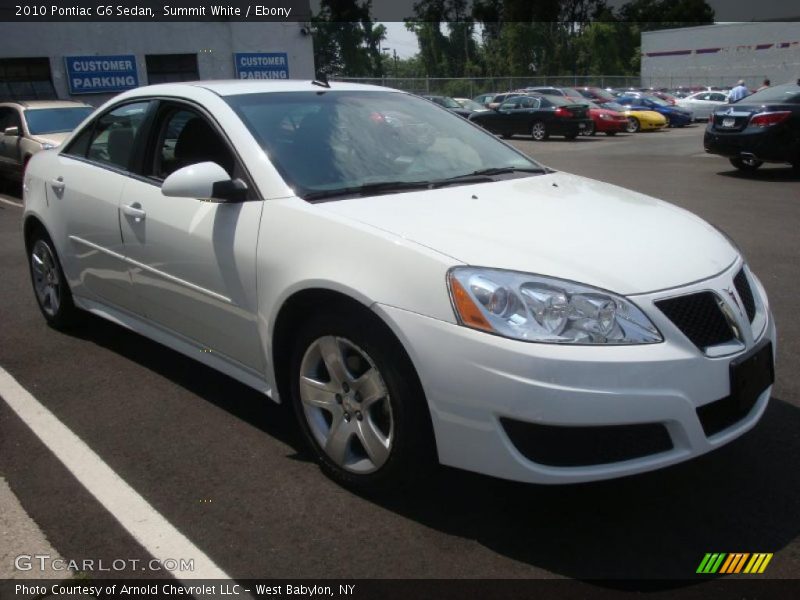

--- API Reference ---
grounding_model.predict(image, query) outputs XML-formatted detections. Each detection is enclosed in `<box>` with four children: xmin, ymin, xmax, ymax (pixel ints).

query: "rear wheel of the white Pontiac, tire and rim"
<box><xmin>28</xmin><ymin>228</ymin><xmax>79</xmax><ymax>331</ymax></box>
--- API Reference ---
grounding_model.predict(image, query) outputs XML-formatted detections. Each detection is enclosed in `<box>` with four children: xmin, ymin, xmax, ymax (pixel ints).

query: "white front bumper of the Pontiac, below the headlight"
<box><xmin>375</xmin><ymin>263</ymin><xmax>775</xmax><ymax>484</ymax></box>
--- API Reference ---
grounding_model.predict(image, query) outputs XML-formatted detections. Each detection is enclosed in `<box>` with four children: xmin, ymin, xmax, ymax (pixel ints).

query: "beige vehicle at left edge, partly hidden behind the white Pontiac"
<box><xmin>0</xmin><ymin>100</ymin><xmax>94</xmax><ymax>180</ymax></box>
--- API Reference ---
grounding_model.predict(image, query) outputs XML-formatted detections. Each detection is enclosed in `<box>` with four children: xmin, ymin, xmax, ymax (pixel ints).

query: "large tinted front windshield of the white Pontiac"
<box><xmin>225</xmin><ymin>91</ymin><xmax>545</xmax><ymax>199</ymax></box>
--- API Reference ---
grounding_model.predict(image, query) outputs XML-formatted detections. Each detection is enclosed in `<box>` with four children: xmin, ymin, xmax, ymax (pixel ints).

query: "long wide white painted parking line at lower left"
<box><xmin>0</xmin><ymin>367</ymin><xmax>230</xmax><ymax>581</ymax></box>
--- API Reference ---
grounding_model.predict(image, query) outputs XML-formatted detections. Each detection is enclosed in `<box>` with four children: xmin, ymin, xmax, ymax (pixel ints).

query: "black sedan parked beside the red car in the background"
<box><xmin>470</xmin><ymin>95</ymin><xmax>592</xmax><ymax>141</ymax></box>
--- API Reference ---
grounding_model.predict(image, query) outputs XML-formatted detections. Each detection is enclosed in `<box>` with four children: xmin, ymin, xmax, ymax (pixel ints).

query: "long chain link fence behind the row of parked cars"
<box><xmin>335</xmin><ymin>75</ymin><xmax>744</xmax><ymax>98</ymax></box>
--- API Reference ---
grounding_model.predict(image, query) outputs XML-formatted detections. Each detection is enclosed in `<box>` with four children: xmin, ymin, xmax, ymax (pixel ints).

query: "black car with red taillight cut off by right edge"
<box><xmin>703</xmin><ymin>83</ymin><xmax>800</xmax><ymax>171</ymax></box>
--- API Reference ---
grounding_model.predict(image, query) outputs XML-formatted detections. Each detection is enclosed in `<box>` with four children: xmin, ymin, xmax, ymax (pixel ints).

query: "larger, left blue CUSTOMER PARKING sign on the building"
<box><xmin>64</xmin><ymin>54</ymin><xmax>139</xmax><ymax>95</ymax></box>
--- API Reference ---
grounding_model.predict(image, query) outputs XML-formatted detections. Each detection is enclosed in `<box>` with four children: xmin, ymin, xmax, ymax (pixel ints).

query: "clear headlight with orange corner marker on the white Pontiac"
<box><xmin>447</xmin><ymin>267</ymin><xmax>662</xmax><ymax>344</ymax></box>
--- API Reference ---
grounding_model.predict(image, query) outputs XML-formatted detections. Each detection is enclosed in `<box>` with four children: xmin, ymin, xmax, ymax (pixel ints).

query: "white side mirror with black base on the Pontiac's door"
<box><xmin>161</xmin><ymin>162</ymin><xmax>247</xmax><ymax>202</ymax></box>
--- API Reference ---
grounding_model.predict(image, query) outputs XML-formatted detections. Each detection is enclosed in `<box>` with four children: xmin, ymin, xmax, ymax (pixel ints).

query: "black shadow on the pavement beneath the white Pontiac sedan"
<box><xmin>67</xmin><ymin>316</ymin><xmax>800</xmax><ymax>589</ymax></box>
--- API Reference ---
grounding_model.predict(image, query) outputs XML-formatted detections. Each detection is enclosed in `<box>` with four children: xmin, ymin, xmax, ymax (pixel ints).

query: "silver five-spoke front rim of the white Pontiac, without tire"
<box><xmin>299</xmin><ymin>335</ymin><xmax>394</xmax><ymax>473</ymax></box>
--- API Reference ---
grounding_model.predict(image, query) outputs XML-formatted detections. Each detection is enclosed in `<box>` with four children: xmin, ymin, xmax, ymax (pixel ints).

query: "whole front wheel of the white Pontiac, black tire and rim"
<box><xmin>290</xmin><ymin>310</ymin><xmax>435</xmax><ymax>493</ymax></box>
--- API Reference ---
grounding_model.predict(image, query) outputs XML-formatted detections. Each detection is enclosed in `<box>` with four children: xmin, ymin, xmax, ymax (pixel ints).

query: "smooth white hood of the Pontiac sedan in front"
<box><xmin>317</xmin><ymin>173</ymin><xmax>737</xmax><ymax>294</ymax></box>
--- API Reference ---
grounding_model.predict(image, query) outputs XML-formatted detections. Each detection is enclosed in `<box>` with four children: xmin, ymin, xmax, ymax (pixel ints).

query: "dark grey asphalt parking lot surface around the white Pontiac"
<box><xmin>0</xmin><ymin>125</ymin><xmax>800</xmax><ymax>579</ymax></box>
